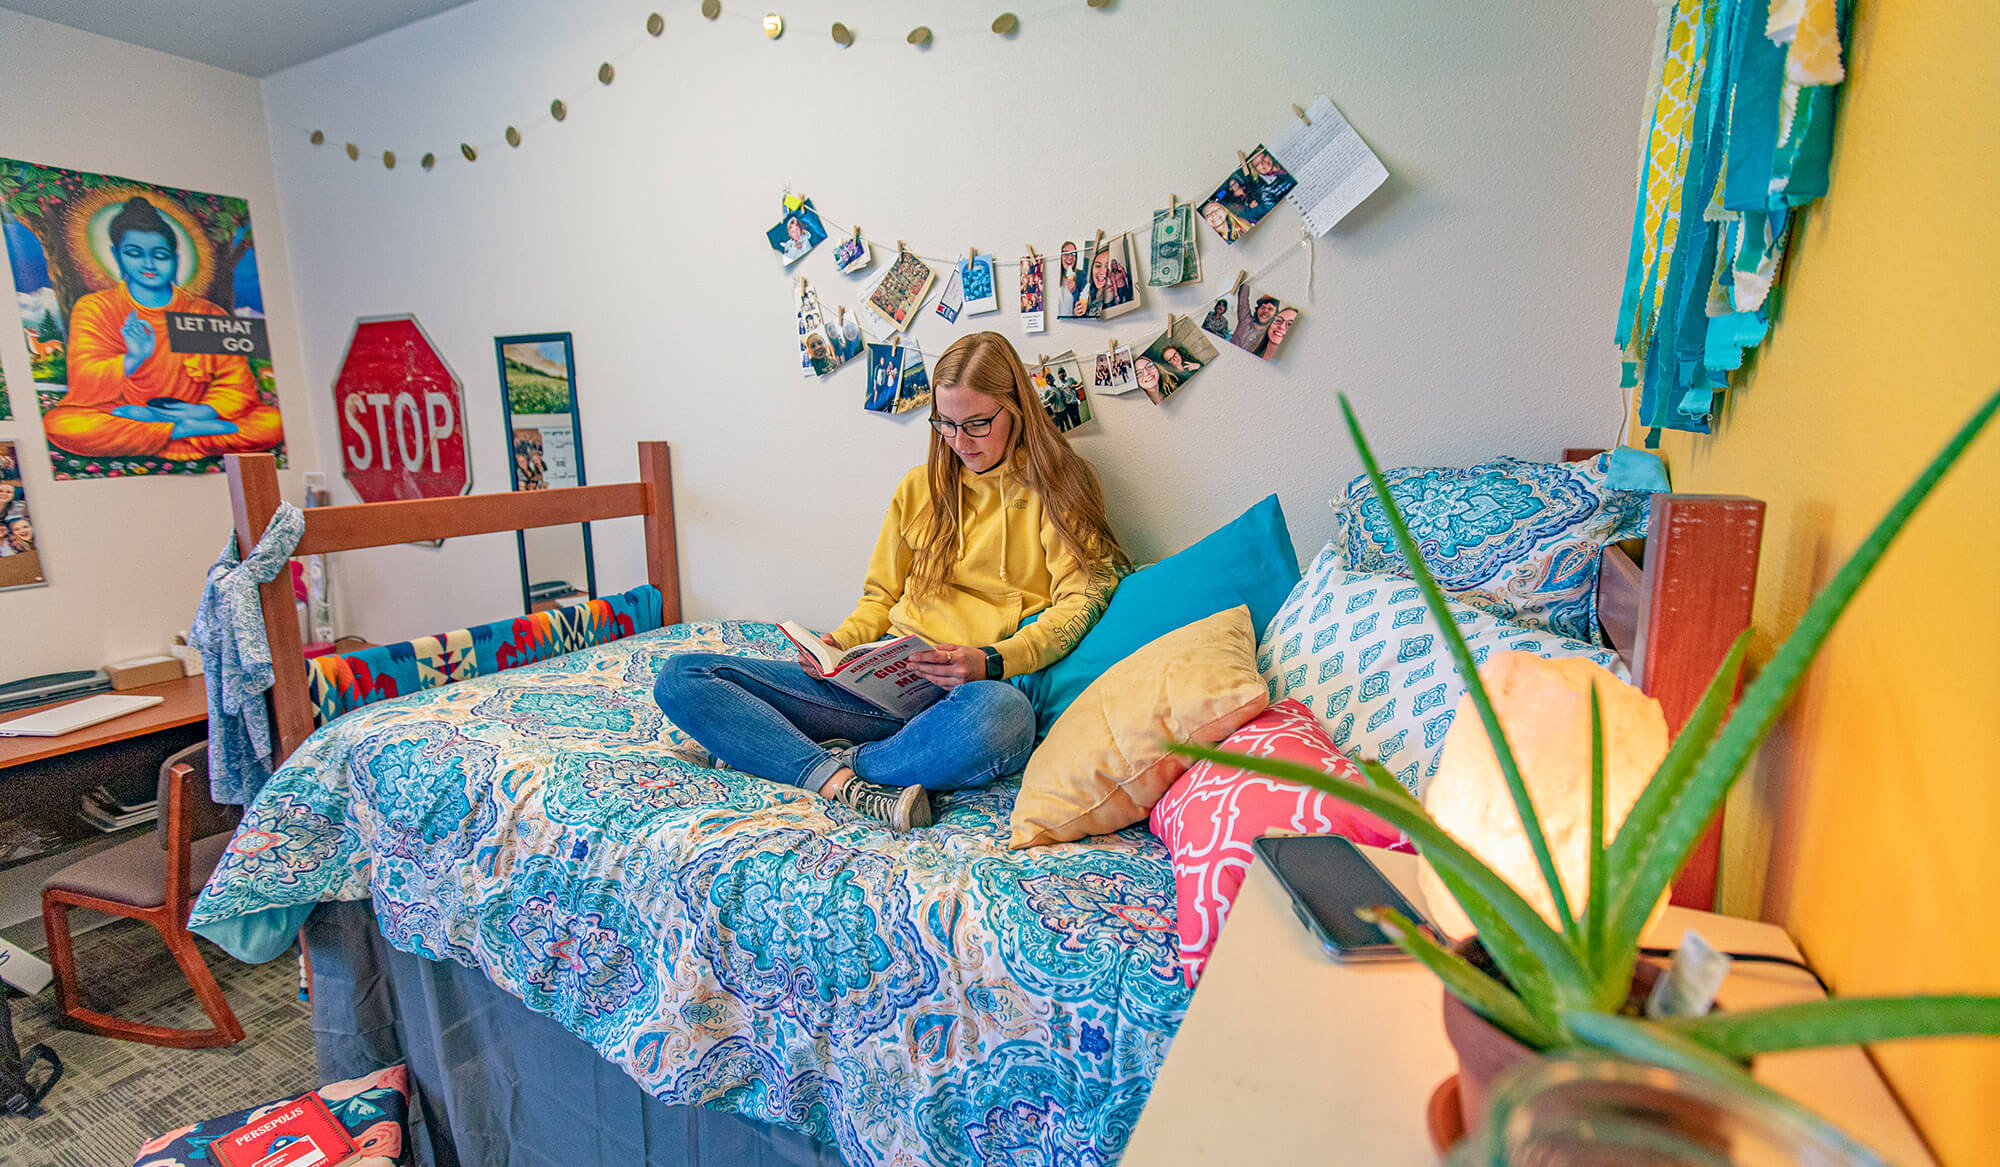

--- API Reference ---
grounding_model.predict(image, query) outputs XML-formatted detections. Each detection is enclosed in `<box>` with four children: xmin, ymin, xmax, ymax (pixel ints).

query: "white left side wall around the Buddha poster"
<box><xmin>0</xmin><ymin>12</ymin><xmax>318</xmax><ymax>681</ymax></box>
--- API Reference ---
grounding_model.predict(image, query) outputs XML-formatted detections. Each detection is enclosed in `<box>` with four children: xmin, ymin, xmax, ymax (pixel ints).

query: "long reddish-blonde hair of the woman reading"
<box><xmin>910</xmin><ymin>332</ymin><xmax>1132</xmax><ymax>597</ymax></box>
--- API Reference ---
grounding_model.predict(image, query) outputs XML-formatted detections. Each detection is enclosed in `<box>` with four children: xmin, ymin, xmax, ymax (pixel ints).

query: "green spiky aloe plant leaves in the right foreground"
<box><xmin>1176</xmin><ymin>392</ymin><xmax>2000</xmax><ymax>1105</ymax></box>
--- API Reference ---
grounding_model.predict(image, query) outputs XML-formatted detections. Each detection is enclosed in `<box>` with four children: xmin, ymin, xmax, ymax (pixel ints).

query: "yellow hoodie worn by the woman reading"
<box><xmin>834</xmin><ymin>452</ymin><xmax>1118</xmax><ymax>677</ymax></box>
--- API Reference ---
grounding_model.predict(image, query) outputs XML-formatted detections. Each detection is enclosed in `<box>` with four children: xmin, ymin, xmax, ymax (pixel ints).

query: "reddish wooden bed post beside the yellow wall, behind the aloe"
<box><xmin>1632</xmin><ymin>494</ymin><xmax>1764</xmax><ymax>909</ymax></box>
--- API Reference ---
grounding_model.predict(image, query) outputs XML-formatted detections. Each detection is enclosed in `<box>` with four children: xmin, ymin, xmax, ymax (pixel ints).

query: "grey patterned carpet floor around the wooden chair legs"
<box><xmin>0</xmin><ymin>921</ymin><xmax>318</xmax><ymax>1167</ymax></box>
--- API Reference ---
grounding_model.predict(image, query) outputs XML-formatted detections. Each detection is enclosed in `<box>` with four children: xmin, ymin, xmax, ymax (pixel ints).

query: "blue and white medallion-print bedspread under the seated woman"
<box><xmin>192</xmin><ymin>623</ymin><xmax>1188</xmax><ymax>1167</ymax></box>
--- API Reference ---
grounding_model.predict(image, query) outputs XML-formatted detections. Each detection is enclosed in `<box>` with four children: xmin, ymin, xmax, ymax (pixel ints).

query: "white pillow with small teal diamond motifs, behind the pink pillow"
<box><xmin>1256</xmin><ymin>544</ymin><xmax>1626</xmax><ymax>793</ymax></box>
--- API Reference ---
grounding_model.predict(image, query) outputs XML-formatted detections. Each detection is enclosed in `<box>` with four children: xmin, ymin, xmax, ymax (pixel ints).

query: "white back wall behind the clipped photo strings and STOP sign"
<box><xmin>264</xmin><ymin>0</ymin><xmax>1652</xmax><ymax>639</ymax></box>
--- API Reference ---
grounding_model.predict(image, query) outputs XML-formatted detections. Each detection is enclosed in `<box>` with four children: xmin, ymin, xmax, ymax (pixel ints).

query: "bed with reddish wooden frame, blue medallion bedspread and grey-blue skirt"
<box><xmin>192</xmin><ymin>442</ymin><xmax>1760</xmax><ymax>1167</ymax></box>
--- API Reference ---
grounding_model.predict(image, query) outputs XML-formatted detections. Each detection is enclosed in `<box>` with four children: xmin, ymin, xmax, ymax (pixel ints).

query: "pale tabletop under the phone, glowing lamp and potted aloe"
<box><xmin>1124</xmin><ymin>849</ymin><xmax>1932</xmax><ymax>1167</ymax></box>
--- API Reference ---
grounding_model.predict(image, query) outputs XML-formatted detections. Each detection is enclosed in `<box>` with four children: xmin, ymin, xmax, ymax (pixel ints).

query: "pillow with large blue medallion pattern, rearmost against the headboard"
<box><xmin>1332</xmin><ymin>450</ymin><xmax>1666</xmax><ymax>643</ymax></box>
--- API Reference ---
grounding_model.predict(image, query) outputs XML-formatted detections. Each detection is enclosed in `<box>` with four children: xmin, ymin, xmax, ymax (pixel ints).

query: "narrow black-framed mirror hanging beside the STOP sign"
<box><xmin>494</xmin><ymin>332</ymin><xmax>598</xmax><ymax>611</ymax></box>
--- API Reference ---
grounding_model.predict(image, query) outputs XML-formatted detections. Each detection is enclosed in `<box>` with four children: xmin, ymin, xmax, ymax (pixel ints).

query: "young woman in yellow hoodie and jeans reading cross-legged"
<box><xmin>654</xmin><ymin>332</ymin><xmax>1130</xmax><ymax>831</ymax></box>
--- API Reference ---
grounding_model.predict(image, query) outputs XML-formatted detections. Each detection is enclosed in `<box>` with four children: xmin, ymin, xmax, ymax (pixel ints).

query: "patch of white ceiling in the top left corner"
<box><xmin>0</xmin><ymin>0</ymin><xmax>466</xmax><ymax>78</ymax></box>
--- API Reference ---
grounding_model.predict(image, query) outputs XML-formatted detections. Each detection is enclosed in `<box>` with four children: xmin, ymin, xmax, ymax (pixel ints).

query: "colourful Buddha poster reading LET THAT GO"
<box><xmin>0</xmin><ymin>160</ymin><xmax>284</xmax><ymax>480</ymax></box>
